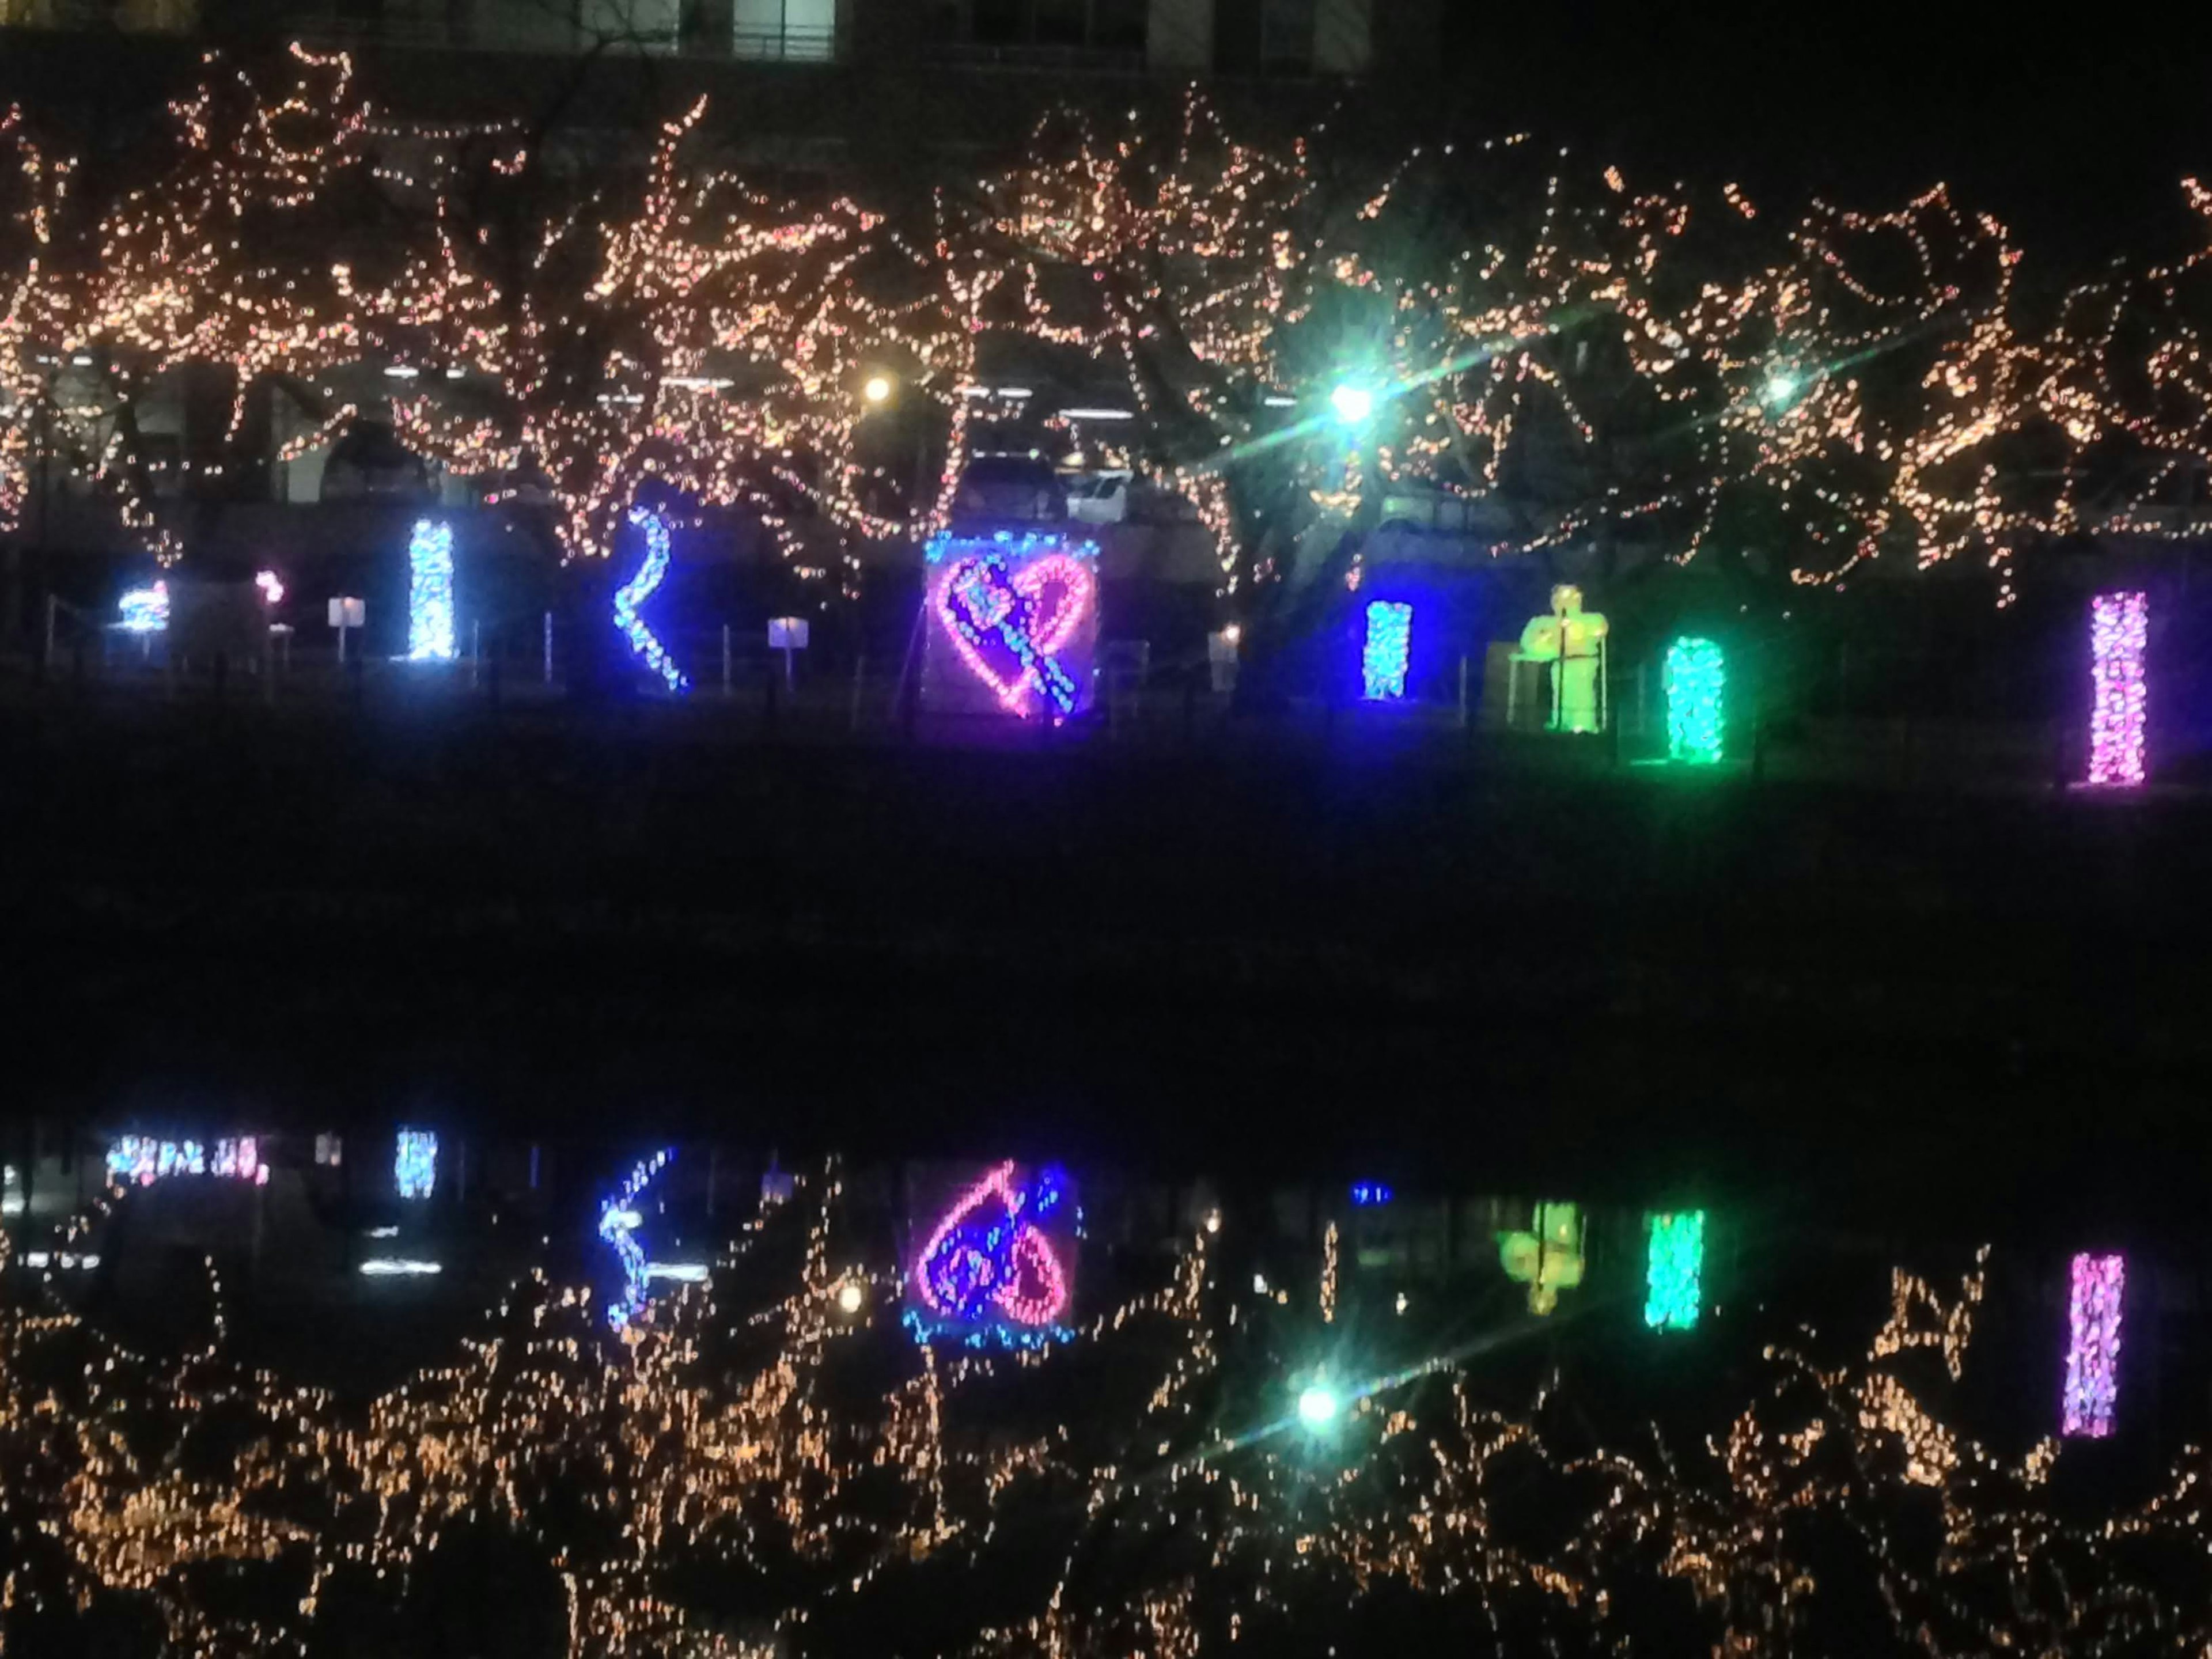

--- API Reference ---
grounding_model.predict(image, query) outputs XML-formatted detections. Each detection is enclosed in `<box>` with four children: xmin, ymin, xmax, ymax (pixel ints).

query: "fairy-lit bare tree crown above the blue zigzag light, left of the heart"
<box><xmin>339</xmin><ymin>90</ymin><xmax>974</xmax><ymax>588</ymax></box>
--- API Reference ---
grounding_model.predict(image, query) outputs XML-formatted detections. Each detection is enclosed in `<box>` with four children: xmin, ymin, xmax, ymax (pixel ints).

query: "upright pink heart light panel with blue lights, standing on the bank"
<box><xmin>929</xmin><ymin>535</ymin><xmax>1097</xmax><ymax>726</ymax></box>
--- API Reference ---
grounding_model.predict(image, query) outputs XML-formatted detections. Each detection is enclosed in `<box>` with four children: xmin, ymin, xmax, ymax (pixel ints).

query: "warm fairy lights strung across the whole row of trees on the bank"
<box><xmin>13</xmin><ymin>60</ymin><xmax>2212</xmax><ymax>619</ymax></box>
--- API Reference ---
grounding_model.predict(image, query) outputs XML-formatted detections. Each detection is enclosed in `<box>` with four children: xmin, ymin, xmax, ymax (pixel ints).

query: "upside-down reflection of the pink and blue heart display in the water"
<box><xmin>909</xmin><ymin>1161</ymin><xmax>1073</xmax><ymax>1340</ymax></box>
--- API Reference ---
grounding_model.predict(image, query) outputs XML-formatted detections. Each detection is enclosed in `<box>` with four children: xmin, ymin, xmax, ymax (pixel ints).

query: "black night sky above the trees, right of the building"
<box><xmin>1440</xmin><ymin>0</ymin><xmax>2212</xmax><ymax>268</ymax></box>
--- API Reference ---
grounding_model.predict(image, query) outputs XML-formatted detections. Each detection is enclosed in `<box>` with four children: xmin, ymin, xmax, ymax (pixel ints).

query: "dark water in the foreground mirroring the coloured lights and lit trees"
<box><xmin>0</xmin><ymin>1130</ymin><xmax>2212</xmax><ymax>1657</ymax></box>
